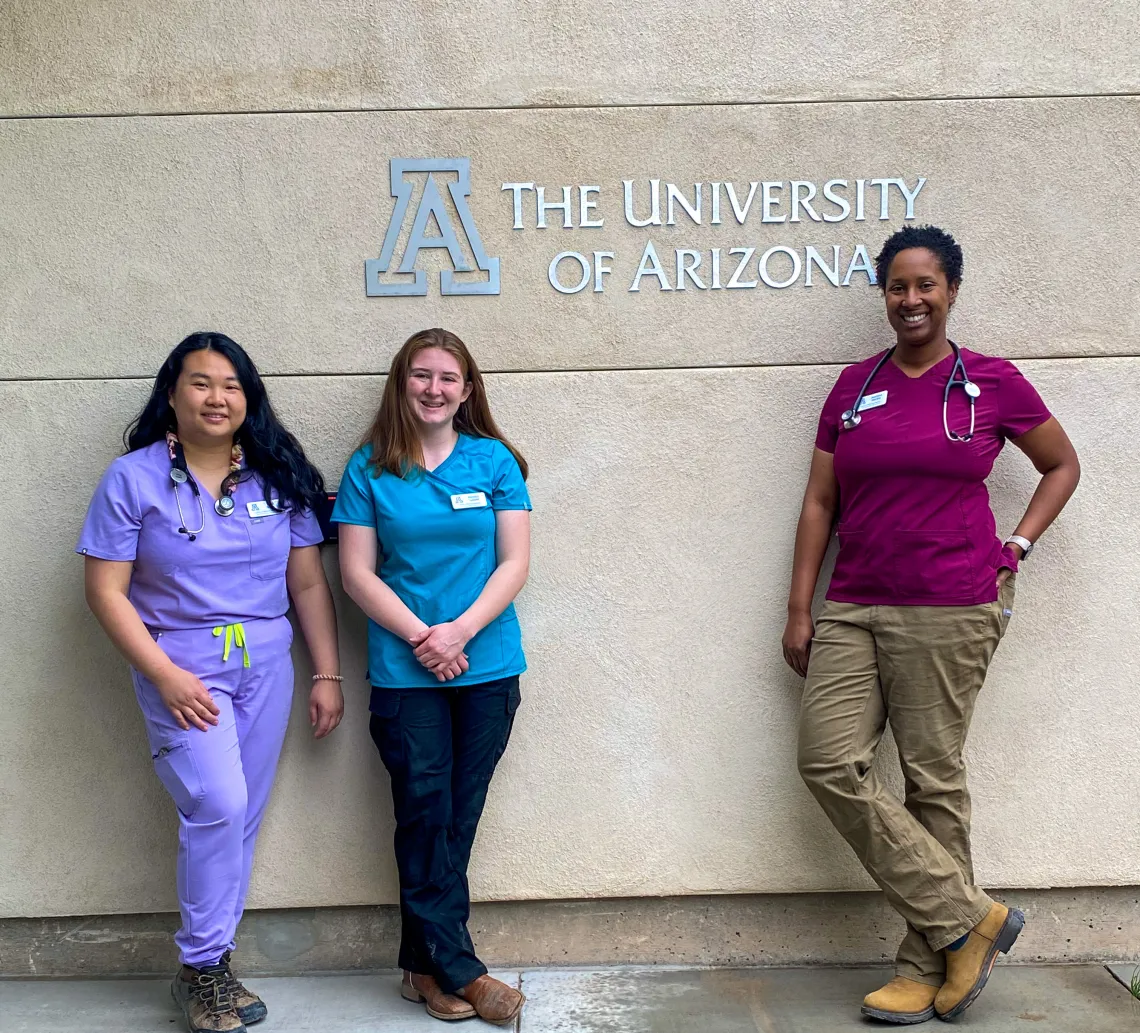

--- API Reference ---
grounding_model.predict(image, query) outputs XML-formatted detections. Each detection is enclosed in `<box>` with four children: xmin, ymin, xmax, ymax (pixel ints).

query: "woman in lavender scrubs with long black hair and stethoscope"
<box><xmin>76</xmin><ymin>333</ymin><xmax>344</xmax><ymax>1033</ymax></box>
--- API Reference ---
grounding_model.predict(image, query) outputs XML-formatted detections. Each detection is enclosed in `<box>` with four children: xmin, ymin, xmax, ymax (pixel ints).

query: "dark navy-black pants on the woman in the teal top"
<box><xmin>368</xmin><ymin>676</ymin><xmax>520</xmax><ymax>992</ymax></box>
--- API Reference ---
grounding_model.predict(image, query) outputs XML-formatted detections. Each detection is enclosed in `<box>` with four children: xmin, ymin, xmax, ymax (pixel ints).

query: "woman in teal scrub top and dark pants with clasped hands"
<box><xmin>333</xmin><ymin>330</ymin><xmax>530</xmax><ymax>1024</ymax></box>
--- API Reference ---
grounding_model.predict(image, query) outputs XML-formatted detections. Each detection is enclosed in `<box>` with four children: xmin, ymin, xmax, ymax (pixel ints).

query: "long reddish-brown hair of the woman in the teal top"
<box><xmin>361</xmin><ymin>327</ymin><xmax>529</xmax><ymax>479</ymax></box>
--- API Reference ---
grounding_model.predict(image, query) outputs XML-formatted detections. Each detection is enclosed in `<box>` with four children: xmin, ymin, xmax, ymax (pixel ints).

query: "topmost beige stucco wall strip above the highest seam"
<box><xmin>0</xmin><ymin>0</ymin><xmax>1140</xmax><ymax>115</ymax></box>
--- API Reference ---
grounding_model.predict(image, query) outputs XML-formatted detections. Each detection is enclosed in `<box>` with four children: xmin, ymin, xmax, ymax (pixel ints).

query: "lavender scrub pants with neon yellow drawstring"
<box><xmin>132</xmin><ymin>617</ymin><xmax>293</xmax><ymax>968</ymax></box>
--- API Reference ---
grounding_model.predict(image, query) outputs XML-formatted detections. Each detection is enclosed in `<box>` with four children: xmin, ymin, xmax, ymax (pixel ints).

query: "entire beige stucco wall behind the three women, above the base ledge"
<box><xmin>0</xmin><ymin>0</ymin><xmax>1140</xmax><ymax>916</ymax></box>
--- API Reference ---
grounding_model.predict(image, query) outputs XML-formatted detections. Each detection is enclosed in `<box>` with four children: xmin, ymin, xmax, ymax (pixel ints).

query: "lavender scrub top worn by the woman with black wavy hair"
<box><xmin>75</xmin><ymin>441</ymin><xmax>324</xmax><ymax>632</ymax></box>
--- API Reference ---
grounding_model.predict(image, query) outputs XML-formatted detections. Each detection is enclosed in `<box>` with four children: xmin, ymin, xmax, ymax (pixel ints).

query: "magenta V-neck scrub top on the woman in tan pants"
<box><xmin>815</xmin><ymin>348</ymin><xmax>1050</xmax><ymax>607</ymax></box>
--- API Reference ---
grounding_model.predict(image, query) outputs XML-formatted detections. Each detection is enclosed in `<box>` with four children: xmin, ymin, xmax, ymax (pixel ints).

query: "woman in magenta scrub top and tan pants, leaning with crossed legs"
<box><xmin>783</xmin><ymin>227</ymin><xmax>1081</xmax><ymax>1024</ymax></box>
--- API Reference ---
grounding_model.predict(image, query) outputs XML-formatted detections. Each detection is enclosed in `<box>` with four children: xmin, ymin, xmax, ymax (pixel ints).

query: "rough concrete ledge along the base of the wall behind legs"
<box><xmin>0</xmin><ymin>886</ymin><xmax>1140</xmax><ymax>978</ymax></box>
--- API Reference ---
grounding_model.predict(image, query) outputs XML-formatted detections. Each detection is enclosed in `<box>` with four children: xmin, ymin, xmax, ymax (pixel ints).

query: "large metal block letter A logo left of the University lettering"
<box><xmin>364</xmin><ymin>157</ymin><xmax>499</xmax><ymax>298</ymax></box>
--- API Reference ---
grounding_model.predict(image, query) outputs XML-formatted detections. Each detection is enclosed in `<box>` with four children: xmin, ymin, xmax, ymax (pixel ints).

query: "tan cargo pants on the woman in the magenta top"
<box><xmin>799</xmin><ymin>577</ymin><xmax>1015</xmax><ymax>986</ymax></box>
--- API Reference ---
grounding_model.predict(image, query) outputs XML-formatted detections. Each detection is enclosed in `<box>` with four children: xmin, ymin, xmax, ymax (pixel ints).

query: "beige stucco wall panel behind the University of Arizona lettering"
<box><xmin>0</xmin><ymin>97</ymin><xmax>1140</xmax><ymax>377</ymax></box>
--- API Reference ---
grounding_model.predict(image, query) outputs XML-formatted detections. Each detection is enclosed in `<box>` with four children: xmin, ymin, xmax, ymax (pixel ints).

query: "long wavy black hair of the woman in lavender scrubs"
<box><xmin>123</xmin><ymin>332</ymin><xmax>325</xmax><ymax>513</ymax></box>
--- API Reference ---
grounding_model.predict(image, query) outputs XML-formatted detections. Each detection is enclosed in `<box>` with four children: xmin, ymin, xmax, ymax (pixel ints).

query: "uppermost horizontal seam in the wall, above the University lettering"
<box><xmin>0</xmin><ymin>90</ymin><xmax>1140</xmax><ymax>122</ymax></box>
